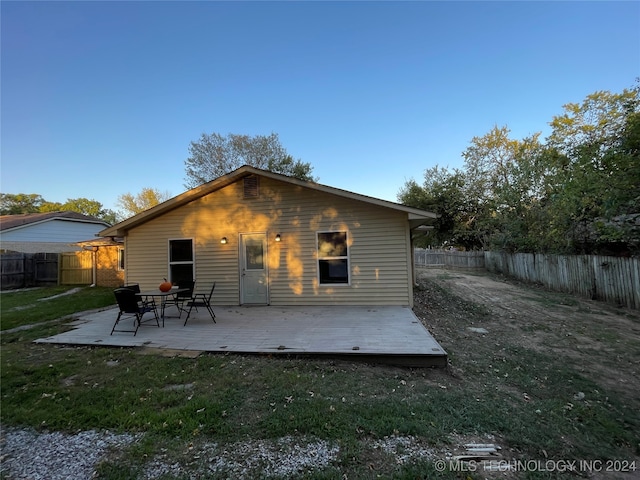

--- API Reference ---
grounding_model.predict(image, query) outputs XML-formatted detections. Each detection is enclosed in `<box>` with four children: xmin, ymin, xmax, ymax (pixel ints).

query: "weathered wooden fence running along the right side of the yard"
<box><xmin>485</xmin><ymin>252</ymin><xmax>640</xmax><ymax>309</ymax></box>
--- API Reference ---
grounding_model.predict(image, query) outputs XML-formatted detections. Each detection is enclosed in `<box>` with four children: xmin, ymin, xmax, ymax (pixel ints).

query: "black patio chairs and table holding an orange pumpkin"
<box><xmin>111</xmin><ymin>281</ymin><xmax>216</xmax><ymax>336</ymax></box>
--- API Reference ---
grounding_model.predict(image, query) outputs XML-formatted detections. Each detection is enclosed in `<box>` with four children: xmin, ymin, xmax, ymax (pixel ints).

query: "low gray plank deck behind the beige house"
<box><xmin>36</xmin><ymin>306</ymin><xmax>447</xmax><ymax>367</ymax></box>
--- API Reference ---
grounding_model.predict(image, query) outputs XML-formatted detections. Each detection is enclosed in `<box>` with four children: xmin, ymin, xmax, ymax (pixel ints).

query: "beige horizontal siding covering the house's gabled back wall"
<box><xmin>126</xmin><ymin>177</ymin><xmax>412</xmax><ymax>305</ymax></box>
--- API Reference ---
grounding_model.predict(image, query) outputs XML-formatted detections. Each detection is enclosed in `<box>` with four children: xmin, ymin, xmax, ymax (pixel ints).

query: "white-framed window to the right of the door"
<box><xmin>316</xmin><ymin>231</ymin><xmax>350</xmax><ymax>285</ymax></box>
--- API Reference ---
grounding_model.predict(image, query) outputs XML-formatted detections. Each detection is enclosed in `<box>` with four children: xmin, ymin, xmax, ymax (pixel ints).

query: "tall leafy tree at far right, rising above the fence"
<box><xmin>547</xmin><ymin>86</ymin><xmax>640</xmax><ymax>253</ymax></box>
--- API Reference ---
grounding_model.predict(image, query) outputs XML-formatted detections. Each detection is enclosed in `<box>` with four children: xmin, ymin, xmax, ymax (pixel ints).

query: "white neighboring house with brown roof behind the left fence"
<box><xmin>0</xmin><ymin>212</ymin><xmax>109</xmax><ymax>253</ymax></box>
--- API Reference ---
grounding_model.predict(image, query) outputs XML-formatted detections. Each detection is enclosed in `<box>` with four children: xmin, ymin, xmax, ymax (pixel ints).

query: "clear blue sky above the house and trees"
<box><xmin>0</xmin><ymin>1</ymin><xmax>640</xmax><ymax>214</ymax></box>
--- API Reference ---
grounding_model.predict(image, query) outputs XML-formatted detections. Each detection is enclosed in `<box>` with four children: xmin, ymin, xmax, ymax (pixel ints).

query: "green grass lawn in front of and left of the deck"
<box><xmin>0</xmin><ymin>285</ymin><xmax>640</xmax><ymax>479</ymax></box>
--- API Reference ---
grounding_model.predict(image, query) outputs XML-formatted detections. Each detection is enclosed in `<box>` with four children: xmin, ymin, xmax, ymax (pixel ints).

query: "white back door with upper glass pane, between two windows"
<box><xmin>240</xmin><ymin>233</ymin><xmax>269</xmax><ymax>305</ymax></box>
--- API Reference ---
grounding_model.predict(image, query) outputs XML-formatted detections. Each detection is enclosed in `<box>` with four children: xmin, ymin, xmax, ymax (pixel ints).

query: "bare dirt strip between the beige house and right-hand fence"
<box><xmin>414</xmin><ymin>269</ymin><xmax>640</xmax><ymax>397</ymax></box>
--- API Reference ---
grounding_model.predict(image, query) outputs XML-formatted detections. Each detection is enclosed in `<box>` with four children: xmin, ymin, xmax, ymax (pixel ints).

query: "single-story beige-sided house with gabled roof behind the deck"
<box><xmin>100</xmin><ymin>166</ymin><xmax>437</xmax><ymax>306</ymax></box>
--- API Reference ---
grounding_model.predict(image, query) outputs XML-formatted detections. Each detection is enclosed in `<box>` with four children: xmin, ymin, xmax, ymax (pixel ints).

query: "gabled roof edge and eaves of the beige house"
<box><xmin>100</xmin><ymin>165</ymin><xmax>438</xmax><ymax>237</ymax></box>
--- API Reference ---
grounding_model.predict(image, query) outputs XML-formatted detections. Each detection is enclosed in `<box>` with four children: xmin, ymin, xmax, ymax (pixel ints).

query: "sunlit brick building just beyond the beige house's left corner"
<box><xmin>78</xmin><ymin>237</ymin><xmax>124</xmax><ymax>288</ymax></box>
